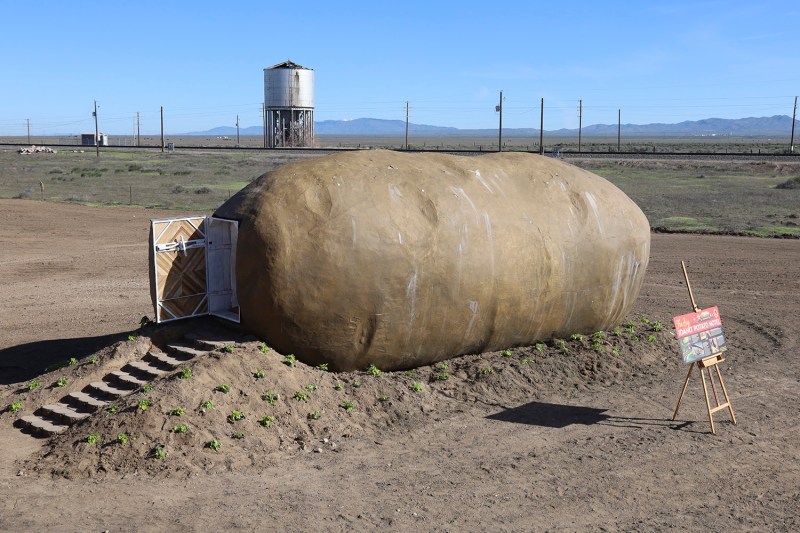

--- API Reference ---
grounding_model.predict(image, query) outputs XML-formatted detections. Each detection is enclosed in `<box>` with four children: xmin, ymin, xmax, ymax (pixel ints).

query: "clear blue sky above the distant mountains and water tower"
<box><xmin>0</xmin><ymin>0</ymin><xmax>800</xmax><ymax>135</ymax></box>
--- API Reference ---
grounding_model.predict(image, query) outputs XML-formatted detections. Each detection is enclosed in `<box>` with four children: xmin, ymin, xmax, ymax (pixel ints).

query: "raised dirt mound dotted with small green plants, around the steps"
<box><xmin>12</xmin><ymin>317</ymin><xmax>675</xmax><ymax>478</ymax></box>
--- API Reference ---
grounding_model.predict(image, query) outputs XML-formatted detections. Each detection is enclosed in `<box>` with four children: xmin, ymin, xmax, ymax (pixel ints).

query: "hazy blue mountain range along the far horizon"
<box><xmin>186</xmin><ymin>115</ymin><xmax>800</xmax><ymax>137</ymax></box>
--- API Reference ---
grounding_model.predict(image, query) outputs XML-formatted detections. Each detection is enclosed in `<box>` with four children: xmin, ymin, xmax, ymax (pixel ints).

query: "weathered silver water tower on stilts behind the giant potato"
<box><xmin>264</xmin><ymin>61</ymin><xmax>314</xmax><ymax>148</ymax></box>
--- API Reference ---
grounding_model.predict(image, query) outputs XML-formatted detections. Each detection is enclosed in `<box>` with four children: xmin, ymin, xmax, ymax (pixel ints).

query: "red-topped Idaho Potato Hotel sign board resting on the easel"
<box><xmin>672</xmin><ymin>306</ymin><xmax>727</xmax><ymax>364</ymax></box>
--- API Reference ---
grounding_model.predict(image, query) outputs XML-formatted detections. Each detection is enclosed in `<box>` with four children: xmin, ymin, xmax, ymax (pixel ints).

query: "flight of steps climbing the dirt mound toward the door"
<box><xmin>14</xmin><ymin>332</ymin><xmax>241</xmax><ymax>437</ymax></box>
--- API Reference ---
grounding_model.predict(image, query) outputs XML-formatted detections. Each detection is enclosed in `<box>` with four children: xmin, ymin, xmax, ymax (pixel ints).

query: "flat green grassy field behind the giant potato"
<box><xmin>0</xmin><ymin>147</ymin><xmax>800</xmax><ymax>238</ymax></box>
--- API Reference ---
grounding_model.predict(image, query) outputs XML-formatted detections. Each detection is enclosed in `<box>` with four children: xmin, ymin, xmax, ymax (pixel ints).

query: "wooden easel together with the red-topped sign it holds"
<box><xmin>672</xmin><ymin>261</ymin><xmax>736</xmax><ymax>433</ymax></box>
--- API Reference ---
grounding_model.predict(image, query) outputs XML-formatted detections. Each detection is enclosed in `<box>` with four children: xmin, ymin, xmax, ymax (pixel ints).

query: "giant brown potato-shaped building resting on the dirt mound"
<box><xmin>216</xmin><ymin>151</ymin><xmax>650</xmax><ymax>370</ymax></box>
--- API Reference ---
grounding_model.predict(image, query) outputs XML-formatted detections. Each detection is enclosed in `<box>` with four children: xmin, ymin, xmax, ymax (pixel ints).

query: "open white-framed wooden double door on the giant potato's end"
<box><xmin>150</xmin><ymin>217</ymin><xmax>240</xmax><ymax>323</ymax></box>
